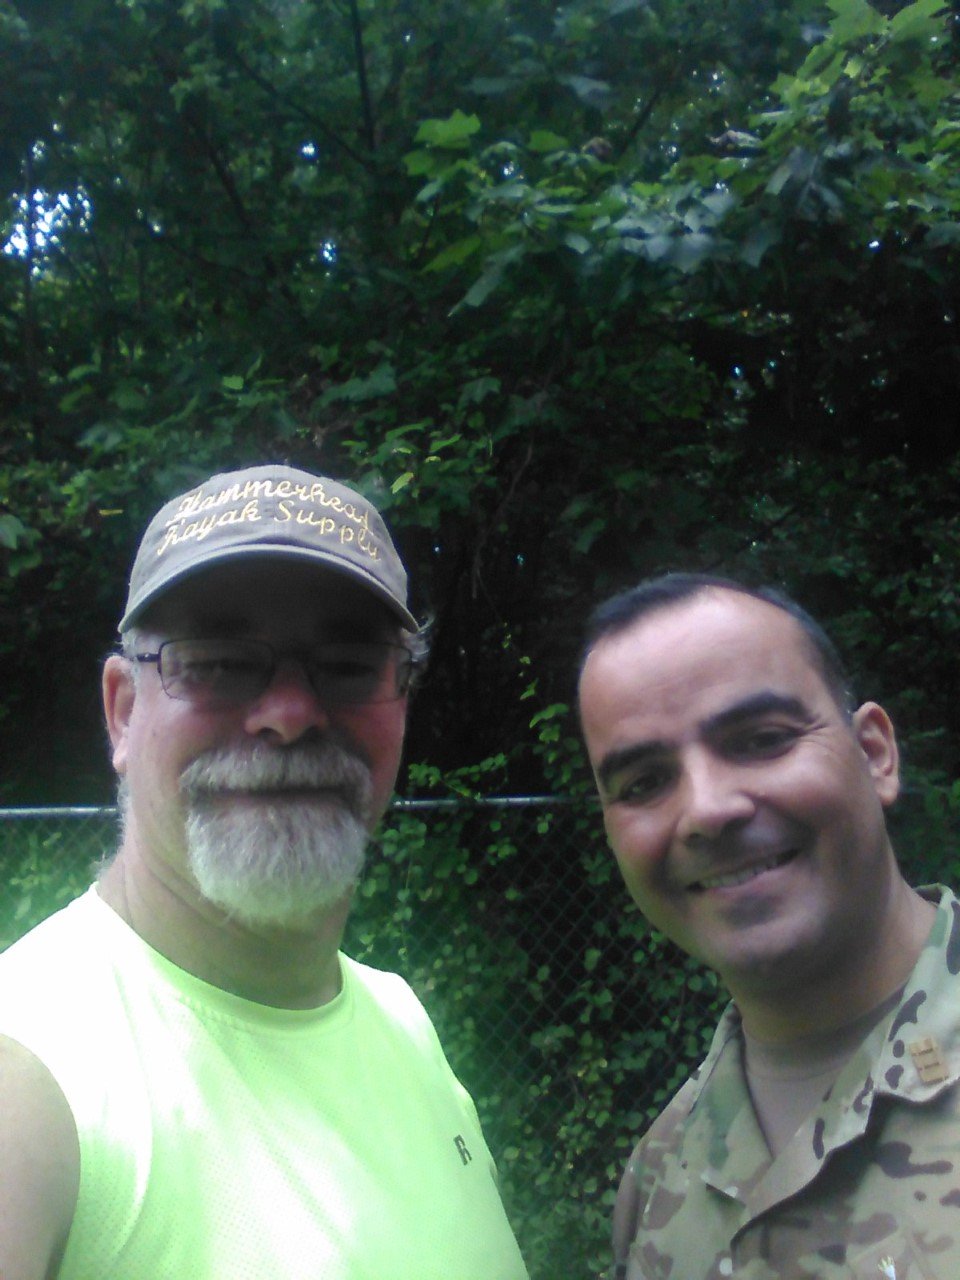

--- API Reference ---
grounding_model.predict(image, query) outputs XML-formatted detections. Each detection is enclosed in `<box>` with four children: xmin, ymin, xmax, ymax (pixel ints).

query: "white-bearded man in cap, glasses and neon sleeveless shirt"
<box><xmin>0</xmin><ymin>466</ymin><xmax>526</xmax><ymax>1280</ymax></box>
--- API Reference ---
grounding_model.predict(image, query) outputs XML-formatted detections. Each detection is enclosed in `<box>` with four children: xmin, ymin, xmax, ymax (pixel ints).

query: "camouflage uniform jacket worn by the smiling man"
<box><xmin>612</xmin><ymin>890</ymin><xmax>960</xmax><ymax>1280</ymax></box>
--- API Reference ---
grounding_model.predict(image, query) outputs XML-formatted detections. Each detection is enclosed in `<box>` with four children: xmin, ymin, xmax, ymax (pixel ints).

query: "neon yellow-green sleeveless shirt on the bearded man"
<box><xmin>0</xmin><ymin>890</ymin><xmax>526</xmax><ymax>1280</ymax></box>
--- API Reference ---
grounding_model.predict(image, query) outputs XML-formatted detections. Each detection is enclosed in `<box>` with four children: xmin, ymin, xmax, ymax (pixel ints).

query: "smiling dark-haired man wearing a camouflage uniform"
<box><xmin>580</xmin><ymin>575</ymin><xmax>960</xmax><ymax>1280</ymax></box>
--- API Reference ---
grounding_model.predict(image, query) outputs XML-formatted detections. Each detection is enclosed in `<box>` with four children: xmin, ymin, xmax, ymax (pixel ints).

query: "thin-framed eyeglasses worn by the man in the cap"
<box><xmin>132</xmin><ymin>639</ymin><xmax>413</xmax><ymax>710</ymax></box>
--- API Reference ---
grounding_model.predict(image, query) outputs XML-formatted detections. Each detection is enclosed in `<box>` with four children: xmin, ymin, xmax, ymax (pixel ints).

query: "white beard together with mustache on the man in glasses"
<box><xmin>180</xmin><ymin>742</ymin><xmax>371</xmax><ymax>927</ymax></box>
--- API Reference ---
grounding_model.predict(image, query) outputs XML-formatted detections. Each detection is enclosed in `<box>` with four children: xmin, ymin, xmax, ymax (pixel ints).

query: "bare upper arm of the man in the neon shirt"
<box><xmin>0</xmin><ymin>1036</ymin><xmax>79</xmax><ymax>1280</ymax></box>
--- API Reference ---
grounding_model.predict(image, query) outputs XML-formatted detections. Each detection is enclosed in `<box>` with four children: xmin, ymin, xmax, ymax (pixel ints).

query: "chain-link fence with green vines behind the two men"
<box><xmin>0</xmin><ymin>797</ymin><xmax>717</xmax><ymax>1280</ymax></box>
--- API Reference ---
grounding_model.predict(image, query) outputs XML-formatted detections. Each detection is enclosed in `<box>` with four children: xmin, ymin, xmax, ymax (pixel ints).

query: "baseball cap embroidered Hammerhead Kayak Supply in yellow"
<box><xmin>119</xmin><ymin>463</ymin><xmax>417</xmax><ymax>632</ymax></box>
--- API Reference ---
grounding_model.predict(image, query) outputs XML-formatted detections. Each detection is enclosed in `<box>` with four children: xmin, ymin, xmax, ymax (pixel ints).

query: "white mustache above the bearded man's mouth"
<box><xmin>180</xmin><ymin>742</ymin><xmax>370</xmax><ymax>813</ymax></box>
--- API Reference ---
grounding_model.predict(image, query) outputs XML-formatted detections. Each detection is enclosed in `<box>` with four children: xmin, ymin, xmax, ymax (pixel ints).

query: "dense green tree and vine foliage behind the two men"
<box><xmin>0</xmin><ymin>0</ymin><xmax>960</xmax><ymax>1275</ymax></box>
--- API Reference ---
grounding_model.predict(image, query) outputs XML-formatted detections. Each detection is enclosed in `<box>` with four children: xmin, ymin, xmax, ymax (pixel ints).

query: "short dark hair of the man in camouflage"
<box><xmin>579</xmin><ymin>573</ymin><xmax>855</xmax><ymax>717</ymax></box>
